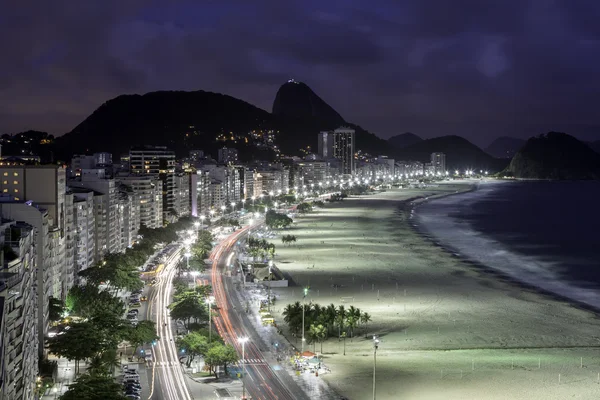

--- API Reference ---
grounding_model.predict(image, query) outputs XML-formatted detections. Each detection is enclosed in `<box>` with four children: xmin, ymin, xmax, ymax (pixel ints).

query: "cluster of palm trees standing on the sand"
<box><xmin>283</xmin><ymin>301</ymin><xmax>371</xmax><ymax>351</ymax></box>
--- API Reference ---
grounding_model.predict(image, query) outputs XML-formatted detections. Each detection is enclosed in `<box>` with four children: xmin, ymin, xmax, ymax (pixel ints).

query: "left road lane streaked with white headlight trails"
<box><xmin>147</xmin><ymin>247</ymin><xmax>193</xmax><ymax>400</ymax></box>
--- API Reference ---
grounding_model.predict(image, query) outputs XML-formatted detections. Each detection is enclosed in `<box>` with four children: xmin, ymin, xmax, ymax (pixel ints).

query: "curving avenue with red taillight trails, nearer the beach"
<box><xmin>210</xmin><ymin>225</ymin><xmax>309</xmax><ymax>400</ymax></box>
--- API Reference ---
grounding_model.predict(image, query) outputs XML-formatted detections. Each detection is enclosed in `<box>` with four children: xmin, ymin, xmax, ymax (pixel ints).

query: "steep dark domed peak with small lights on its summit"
<box><xmin>273</xmin><ymin>79</ymin><xmax>346</xmax><ymax>126</ymax></box>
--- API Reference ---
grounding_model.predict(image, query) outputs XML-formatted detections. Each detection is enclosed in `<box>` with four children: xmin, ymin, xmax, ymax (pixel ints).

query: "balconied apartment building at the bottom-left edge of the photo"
<box><xmin>0</xmin><ymin>222</ymin><xmax>38</xmax><ymax>400</ymax></box>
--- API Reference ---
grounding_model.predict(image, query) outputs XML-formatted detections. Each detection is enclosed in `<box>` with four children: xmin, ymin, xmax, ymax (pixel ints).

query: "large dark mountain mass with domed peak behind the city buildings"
<box><xmin>54</xmin><ymin>82</ymin><xmax>389</xmax><ymax>161</ymax></box>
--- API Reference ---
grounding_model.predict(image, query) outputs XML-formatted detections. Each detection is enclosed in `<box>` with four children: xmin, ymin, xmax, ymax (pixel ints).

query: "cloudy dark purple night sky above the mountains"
<box><xmin>0</xmin><ymin>0</ymin><xmax>600</xmax><ymax>145</ymax></box>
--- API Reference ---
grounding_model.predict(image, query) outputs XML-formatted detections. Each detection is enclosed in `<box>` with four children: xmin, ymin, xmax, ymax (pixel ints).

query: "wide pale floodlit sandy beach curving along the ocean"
<box><xmin>273</xmin><ymin>183</ymin><xmax>600</xmax><ymax>400</ymax></box>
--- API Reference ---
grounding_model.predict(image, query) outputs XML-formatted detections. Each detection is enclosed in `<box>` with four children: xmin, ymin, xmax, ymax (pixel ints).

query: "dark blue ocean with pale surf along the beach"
<box><xmin>413</xmin><ymin>181</ymin><xmax>600</xmax><ymax>310</ymax></box>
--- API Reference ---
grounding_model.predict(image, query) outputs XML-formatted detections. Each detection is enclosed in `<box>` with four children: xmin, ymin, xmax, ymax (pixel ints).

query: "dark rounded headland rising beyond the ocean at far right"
<box><xmin>505</xmin><ymin>132</ymin><xmax>600</xmax><ymax>179</ymax></box>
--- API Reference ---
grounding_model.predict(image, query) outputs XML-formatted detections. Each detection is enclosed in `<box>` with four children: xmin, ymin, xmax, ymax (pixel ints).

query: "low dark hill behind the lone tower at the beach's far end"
<box><xmin>394</xmin><ymin>135</ymin><xmax>507</xmax><ymax>171</ymax></box>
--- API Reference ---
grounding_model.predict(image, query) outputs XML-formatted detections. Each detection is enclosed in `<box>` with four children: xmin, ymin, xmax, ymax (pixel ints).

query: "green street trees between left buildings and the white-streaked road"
<box><xmin>47</xmin><ymin>218</ymin><xmax>197</xmax><ymax>400</ymax></box>
